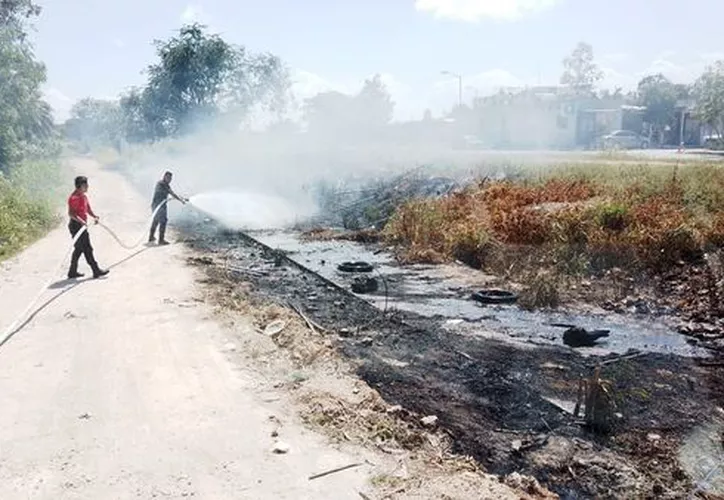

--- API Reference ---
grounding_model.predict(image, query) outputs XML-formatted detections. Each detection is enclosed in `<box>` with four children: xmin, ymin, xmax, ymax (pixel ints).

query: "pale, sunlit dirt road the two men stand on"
<box><xmin>0</xmin><ymin>160</ymin><xmax>368</xmax><ymax>500</ymax></box>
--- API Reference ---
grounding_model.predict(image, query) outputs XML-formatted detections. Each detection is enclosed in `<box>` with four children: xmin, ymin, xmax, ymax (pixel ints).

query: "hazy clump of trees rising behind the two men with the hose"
<box><xmin>66</xmin><ymin>23</ymin><xmax>290</xmax><ymax>142</ymax></box>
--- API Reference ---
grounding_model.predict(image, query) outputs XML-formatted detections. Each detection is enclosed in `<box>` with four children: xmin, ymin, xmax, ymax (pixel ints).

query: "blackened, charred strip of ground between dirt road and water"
<box><xmin>182</xmin><ymin>224</ymin><xmax>724</xmax><ymax>498</ymax></box>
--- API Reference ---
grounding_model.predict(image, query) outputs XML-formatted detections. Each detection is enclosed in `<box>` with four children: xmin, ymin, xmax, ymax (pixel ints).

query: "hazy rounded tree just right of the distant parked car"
<box><xmin>637</xmin><ymin>73</ymin><xmax>681</xmax><ymax>142</ymax></box>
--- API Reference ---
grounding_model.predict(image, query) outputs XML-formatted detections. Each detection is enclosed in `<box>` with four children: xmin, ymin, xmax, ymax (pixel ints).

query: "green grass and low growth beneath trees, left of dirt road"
<box><xmin>0</xmin><ymin>161</ymin><xmax>67</xmax><ymax>260</ymax></box>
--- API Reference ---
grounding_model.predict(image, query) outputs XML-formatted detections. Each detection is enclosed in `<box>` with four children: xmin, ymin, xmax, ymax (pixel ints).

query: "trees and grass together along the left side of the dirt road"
<box><xmin>0</xmin><ymin>0</ymin><xmax>60</xmax><ymax>260</ymax></box>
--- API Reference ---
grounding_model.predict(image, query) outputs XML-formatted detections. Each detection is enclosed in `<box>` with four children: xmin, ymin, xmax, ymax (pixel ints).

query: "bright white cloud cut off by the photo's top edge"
<box><xmin>415</xmin><ymin>0</ymin><xmax>562</xmax><ymax>23</ymax></box>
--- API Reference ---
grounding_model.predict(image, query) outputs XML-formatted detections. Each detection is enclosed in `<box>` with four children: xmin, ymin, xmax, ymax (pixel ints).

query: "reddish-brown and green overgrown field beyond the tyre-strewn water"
<box><xmin>384</xmin><ymin>162</ymin><xmax>724</xmax><ymax>274</ymax></box>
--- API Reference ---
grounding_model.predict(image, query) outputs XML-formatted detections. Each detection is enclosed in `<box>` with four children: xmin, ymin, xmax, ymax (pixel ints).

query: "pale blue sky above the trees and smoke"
<box><xmin>34</xmin><ymin>0</ymin><xmax>724</xmax><ymax>119</ymax></box>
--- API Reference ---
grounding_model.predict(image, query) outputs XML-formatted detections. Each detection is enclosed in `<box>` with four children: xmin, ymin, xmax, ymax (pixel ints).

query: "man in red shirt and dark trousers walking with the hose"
<box><xmin>68</xmin><ymin>176</ymin><xmax>108</xmax><ymax>279</ymax></box>
